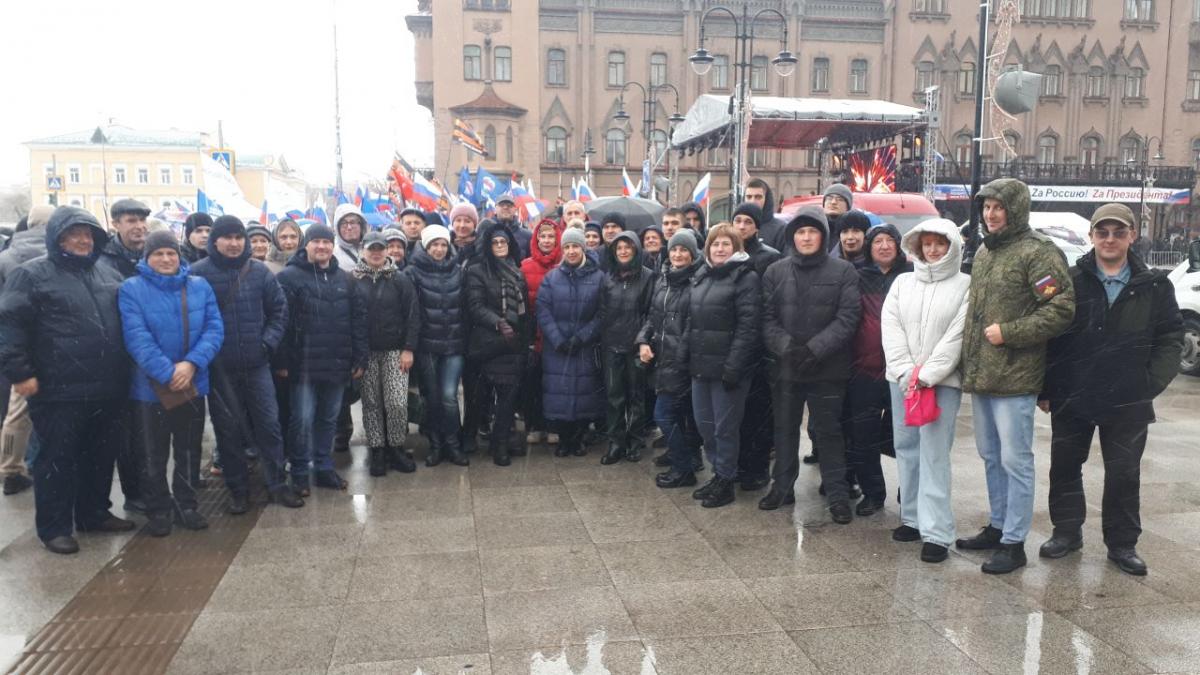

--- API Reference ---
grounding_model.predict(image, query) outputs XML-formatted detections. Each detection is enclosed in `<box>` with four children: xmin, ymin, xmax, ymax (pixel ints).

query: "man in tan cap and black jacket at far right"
<box><xmin>1038</xmin><ymin>199</ymin><xmax>1183</xmax><ymax>577</ymax></box>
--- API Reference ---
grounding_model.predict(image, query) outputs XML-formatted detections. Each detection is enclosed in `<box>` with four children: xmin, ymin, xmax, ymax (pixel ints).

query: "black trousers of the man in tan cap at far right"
<box><xmin>1050</xmin><ymin>413</ymin><xmax>1147</xmax><ymax>549</ymax></box>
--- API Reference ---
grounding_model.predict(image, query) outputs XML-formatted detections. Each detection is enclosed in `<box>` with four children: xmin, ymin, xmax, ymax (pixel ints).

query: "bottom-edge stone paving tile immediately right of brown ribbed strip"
<box><xmin>168</xmin><ymin>605</ymin><xmax>343</xmax><ymax>675</ymax></box>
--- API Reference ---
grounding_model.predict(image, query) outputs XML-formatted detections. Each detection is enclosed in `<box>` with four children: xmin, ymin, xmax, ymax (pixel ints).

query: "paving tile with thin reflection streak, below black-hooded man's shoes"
<box><xmin>708</xmin><ymin>530</ymin><xmax>854</xmax><ymax>579</ymax></box>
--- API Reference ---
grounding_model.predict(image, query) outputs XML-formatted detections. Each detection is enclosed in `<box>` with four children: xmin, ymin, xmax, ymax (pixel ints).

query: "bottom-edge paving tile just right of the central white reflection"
<box><xmin>646</xmin><ymin>633</ymin><xmax>825</xmax><ymax>675</ymax></box>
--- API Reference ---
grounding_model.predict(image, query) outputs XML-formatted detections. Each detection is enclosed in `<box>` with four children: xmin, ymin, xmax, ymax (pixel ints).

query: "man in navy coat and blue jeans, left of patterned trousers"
<box><xmin>274</xmin><ymin>225</ymin><xmax>367</xmax><ymax>497</ymax></box>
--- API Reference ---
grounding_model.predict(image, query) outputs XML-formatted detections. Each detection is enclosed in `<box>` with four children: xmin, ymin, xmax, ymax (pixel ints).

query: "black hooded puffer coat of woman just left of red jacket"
<box><xmin>466</xmin><ymin>223</ymin><xmax>533</xmax><ymax>360</ymax></box>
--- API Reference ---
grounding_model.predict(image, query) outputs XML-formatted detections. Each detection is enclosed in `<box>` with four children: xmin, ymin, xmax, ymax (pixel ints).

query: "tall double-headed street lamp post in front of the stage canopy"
<box><xmin>688</xmin><ymin>4</ymin><xmax>797</xmax><ymax>202</ymax></box>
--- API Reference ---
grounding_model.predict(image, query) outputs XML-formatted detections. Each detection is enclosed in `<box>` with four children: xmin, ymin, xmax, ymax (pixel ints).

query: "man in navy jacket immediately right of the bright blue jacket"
<box><xmin>192</xmin><ymin>216</ymin><xmax>304</xmax><ymax>515</ymax></box>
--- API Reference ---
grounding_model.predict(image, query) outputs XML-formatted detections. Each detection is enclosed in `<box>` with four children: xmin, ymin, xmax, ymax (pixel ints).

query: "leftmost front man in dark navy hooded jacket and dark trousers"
<box><xmin>0</xmin><ymin>207</ymin><xmax>133</xmax><ymax>554</ymax></box>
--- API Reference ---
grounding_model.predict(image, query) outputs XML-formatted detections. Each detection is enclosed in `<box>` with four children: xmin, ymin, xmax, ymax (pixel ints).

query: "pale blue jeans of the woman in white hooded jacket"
<box><xmin>890</xmin><ymin>382</ymin><xmax>962</xmax><ymax>548</ymax></box>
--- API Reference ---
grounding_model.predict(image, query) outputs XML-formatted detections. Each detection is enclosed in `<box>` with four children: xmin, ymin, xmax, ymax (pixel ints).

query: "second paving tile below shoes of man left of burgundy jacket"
<box><xmin>746</xmin><ymin>572</ymin><xmax>914</xmax><ymax>631</ymax></box>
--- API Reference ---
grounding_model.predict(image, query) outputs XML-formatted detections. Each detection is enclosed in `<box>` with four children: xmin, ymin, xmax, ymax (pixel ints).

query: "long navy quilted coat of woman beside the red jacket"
<box><xmin>538</xmin><ymin>257</ymin><xmax>605</xmax><ymax>422</ymax></box>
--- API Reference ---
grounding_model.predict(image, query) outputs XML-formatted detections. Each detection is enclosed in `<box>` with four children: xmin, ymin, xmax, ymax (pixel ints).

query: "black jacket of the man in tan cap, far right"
<box><xmin>1039</xmin><ymin>250</ymin><xmax>1183</xmax><ymax>424</ymax></box>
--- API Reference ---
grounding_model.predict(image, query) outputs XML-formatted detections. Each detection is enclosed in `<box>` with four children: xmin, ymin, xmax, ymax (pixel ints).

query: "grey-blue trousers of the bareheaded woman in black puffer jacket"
<box><xmin>691</xmin><ymin>376</ymin><xmax>750</xmax><ymax>480</ymax></box>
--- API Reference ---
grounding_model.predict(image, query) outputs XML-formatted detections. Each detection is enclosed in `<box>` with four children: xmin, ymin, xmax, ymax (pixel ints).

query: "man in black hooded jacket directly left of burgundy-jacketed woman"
<box><xmin>758</xmin><ymin>207</ymin><xmax>862</xmax><ymax>524</ymax></box>
